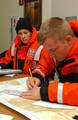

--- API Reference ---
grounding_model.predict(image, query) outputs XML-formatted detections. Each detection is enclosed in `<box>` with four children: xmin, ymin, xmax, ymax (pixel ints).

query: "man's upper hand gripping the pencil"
<box><xmin>26</xmin><ymin>77</ymin><xmax>40</xmax><ymax>89</ymax></box>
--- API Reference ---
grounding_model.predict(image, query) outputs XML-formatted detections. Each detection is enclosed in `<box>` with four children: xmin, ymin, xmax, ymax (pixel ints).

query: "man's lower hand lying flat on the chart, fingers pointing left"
<box><xmin>20</xmin><ymin>87</ymin><xmax>41</xmax><ymax>100</ymax></box>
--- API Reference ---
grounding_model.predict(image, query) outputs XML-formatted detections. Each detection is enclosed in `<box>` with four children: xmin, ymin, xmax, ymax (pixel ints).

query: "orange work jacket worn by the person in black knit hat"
<box><xmin>0</xmin><ymin>28</ymin><xmax>52</xmax><ymax>75</ymax></box>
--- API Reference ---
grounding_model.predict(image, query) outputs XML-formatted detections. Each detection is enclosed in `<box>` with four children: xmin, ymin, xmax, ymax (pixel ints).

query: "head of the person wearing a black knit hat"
<box><xmin>16</xmin><ymin>18</ymin><xmax>33</xmax><ymax>43</ymax></box>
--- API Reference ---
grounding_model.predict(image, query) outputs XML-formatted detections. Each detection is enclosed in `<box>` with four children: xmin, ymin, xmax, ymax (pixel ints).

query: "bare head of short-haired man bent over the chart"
<box><xmin>39</xmin><ymin>17</ymin><xmax>74</xmax><ymax>62</ymax></box>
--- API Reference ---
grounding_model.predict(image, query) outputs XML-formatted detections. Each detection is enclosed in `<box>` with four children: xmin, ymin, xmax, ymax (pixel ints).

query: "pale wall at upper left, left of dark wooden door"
<box><xmin>0</xmin><ymin>0</ymin><xmax>23</xmax><ymax>50</ymax></box>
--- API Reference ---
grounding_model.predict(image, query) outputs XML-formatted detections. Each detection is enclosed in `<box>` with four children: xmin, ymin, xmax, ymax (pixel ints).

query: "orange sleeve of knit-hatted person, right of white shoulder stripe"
<box><xmin>38</xmin><ymin>49</ymin><xmax>55</xmax><ymax>75</ymax></box>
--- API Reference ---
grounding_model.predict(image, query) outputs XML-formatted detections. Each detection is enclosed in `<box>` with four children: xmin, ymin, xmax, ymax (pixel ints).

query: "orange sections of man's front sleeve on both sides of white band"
<box><xmin>48</xmin><ymin>82</ymin><xmax>78</xmax><ymax>106</ymax></box>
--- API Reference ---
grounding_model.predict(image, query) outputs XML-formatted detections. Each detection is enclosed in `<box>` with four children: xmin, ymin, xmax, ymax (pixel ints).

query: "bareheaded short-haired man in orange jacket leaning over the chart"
<box><xmin>20</xmin><ymin>17</ymin><xmax>78</xmax><ymax>106</ymax></box>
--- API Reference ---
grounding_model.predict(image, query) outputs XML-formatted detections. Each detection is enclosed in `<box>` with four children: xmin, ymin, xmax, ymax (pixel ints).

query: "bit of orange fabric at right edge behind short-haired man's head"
<box><xmin>68</xmin><ymin>20</ymin><xmax>78</xmax><ymax>37</ymax></box>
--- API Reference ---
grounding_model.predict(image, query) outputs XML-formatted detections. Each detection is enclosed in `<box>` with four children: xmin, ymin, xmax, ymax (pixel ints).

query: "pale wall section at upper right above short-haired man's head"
<box><xmin>52</xmin><ymin>0</ymin><xmax>78</xmax><ymax>18</ymax></box>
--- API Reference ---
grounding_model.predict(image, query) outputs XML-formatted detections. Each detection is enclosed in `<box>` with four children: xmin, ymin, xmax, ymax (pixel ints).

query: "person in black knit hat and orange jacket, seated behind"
<box><xmin>0</xmin><ymin>18</ymin><xmax>53</xmax><ymax>78</ymax></box>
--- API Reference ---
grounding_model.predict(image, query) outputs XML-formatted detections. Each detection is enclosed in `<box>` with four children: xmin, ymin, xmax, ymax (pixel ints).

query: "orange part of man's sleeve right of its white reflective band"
<box><xmin>63</xmin><ymin>82</ymin><xmax>78</xmax><ymax>106</ymax></box>
